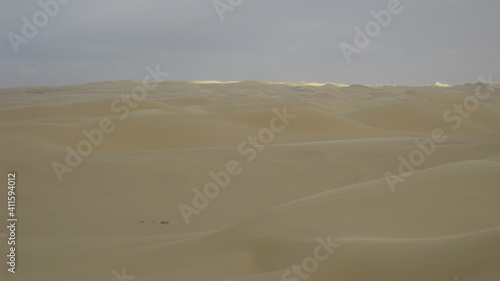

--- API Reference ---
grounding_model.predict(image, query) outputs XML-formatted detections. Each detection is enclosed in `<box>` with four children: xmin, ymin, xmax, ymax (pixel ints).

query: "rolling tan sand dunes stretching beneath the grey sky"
<box><xmin>0</xmin><ymin>81</ymin><xmax>500</xmax><ymax>281</ymax></box>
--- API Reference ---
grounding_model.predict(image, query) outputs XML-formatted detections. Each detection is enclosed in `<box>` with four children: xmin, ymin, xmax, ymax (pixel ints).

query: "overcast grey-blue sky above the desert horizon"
<box><xmin>0</xmin><ymin>0</ymin><xmax>500</xmax><ymax>88</ymax></box>
